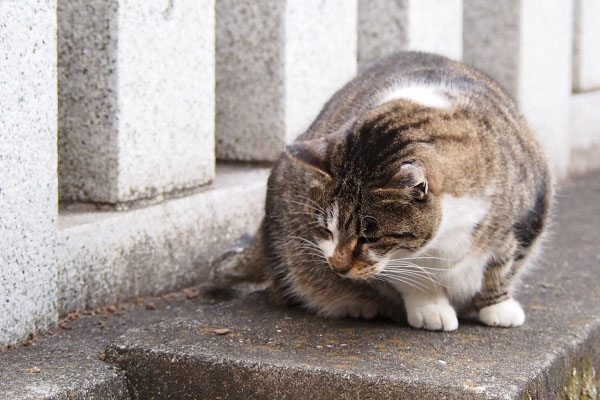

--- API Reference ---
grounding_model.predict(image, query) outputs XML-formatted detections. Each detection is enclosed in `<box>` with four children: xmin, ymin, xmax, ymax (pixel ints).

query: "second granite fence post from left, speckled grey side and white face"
<box><xmin>58</xmin><ymin>0</ymin><xmax>215</xmax><ymax>203</ymax></box>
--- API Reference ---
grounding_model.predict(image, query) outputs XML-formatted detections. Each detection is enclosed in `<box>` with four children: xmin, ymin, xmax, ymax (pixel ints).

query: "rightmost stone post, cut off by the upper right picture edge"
<box><xmin>573</xmin><ymin>0</ymin><xmax>600</xmax><ymax>91</ymax></box>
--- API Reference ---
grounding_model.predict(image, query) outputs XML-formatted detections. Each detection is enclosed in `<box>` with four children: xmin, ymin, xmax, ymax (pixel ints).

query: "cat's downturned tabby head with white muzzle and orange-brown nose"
<box><xmin>287</xmin><ymin>99</ymin><xmax>441</xmax><ymax>279</ymax></box>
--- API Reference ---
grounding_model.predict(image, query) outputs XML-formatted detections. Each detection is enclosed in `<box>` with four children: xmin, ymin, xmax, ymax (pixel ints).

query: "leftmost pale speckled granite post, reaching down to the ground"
<box><xmin>0</xmin><ymin>0</ymin><xmax>57</xmax><ymax>347</ymax></box>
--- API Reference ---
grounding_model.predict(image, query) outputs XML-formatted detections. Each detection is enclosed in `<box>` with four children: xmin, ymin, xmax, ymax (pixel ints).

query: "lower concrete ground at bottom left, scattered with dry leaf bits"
<box><xmin>0</xmin><ymin>282</ymin><xmax>238</xmax><ymax>400</ymax></box>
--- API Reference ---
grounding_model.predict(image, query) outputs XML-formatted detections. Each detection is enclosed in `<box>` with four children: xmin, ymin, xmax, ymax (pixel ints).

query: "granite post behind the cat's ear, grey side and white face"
<box><xmin>216</xmin><ymin>0</ymin><xmax>357</xmax><ymax>161</ymax></box>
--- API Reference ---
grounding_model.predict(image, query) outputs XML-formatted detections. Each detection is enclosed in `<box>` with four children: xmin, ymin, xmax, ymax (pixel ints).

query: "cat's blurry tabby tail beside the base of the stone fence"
<box><xmin>209</xmin><ymin>227</ymin><xmax>266</xmax><ymax>288</ymax></box>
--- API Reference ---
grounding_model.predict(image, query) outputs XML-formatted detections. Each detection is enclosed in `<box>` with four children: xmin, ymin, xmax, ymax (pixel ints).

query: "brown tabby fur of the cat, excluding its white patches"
<box><xmin>212</xmin><ymin>52</ymin><xmax>552</xmax><ymax>324</ymax></box>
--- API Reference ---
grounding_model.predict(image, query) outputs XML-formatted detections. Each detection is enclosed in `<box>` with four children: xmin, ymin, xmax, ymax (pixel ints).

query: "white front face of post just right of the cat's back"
<box><xmin>518</xmin><ymin>0</ymin><xmax>573</xmax><ymax>177</ymax></box>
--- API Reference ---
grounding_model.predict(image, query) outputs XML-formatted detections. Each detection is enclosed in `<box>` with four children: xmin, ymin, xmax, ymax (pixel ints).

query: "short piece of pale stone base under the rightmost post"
<box><xmin>569</xmin><ymin>90</ymin><xmax>600</xmax><ymax>174</ymax></box>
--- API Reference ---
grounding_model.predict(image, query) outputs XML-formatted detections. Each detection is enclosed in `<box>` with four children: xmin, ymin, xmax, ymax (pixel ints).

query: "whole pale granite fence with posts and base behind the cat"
<box><xmin>0</xmin><ymin>0</ymin><xmax>600</xmax><ymax>346</ymax></box>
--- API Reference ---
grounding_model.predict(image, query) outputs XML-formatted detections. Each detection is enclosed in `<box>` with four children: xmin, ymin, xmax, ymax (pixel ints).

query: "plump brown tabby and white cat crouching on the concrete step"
<box><xmin>211</xmin><ymin>52</ymin><xmax>553</xmax><ymax>331</ymax></box>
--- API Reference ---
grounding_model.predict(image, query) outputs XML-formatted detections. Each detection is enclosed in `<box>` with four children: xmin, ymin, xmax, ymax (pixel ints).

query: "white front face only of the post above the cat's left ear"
<box><xmin>284</xmin><ymin>0</ymin><xmax>357</xmax><ymax>143</ymax></box>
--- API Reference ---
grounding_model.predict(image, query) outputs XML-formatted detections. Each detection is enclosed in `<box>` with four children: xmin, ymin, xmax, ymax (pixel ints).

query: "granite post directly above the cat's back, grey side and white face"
<box><xmin>358</xmin><ymin>0</ymin><xmax>463</xmax><ymax>69</ymax></box>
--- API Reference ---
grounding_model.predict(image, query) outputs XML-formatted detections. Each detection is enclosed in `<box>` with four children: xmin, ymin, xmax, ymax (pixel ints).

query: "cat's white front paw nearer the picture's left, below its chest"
<box><xmin>402</xmin><ymin>292</ymin><xmax>458</xmax><ymax>331</ymax></box>
